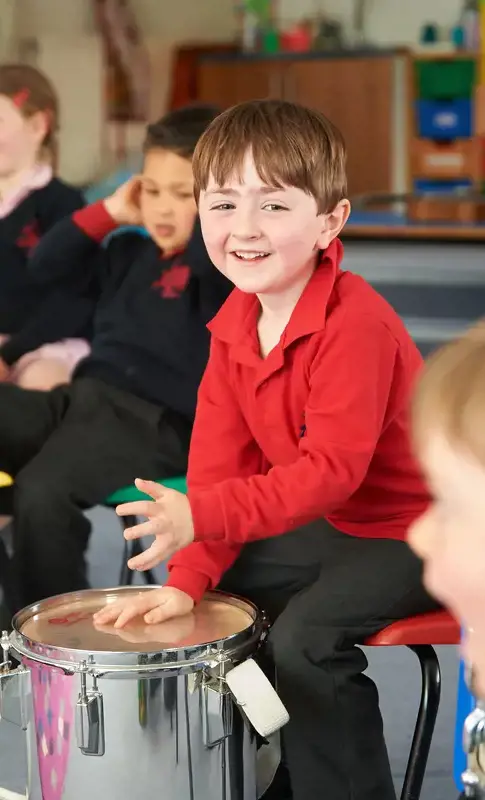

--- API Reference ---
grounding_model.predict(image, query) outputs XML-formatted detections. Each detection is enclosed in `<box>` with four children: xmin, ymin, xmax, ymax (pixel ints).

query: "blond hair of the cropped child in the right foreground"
<box><xmin>413</xmin><ymin>322</ymin><xmax>485</xmax><ymax>466</ymax></box>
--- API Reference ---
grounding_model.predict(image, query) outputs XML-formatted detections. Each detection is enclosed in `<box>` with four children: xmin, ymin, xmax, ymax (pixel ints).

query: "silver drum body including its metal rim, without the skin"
<box><xmin>0</xmin><ymin>588</ymin><xmax>264</xmax><ymax>800</ymax></box>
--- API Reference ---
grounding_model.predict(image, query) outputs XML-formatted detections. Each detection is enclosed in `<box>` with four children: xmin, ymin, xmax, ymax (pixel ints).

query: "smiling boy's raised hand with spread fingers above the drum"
<box><xmin>116</xmin><ymin>479</ymin><xmax>194</xmax><ymax>570</ymax></box>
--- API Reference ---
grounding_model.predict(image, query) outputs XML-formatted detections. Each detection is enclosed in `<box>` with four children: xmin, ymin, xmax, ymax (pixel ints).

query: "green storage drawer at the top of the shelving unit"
<box><xmin>415</xmin><ymin>58</ymin><xmax>477</xmax><ymax>100</ymax></box>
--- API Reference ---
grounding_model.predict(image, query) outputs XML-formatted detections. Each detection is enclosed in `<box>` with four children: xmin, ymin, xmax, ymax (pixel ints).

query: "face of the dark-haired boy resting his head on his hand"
<box><xmin>140</xmin><ymin>149</ymin><xmax>197</xmax><ymax>256</ymax></box>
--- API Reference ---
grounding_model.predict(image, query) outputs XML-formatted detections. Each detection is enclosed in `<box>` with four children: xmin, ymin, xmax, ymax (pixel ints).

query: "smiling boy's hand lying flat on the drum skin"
<box><xmin>93</xmin><ymin>586</ymin><xmax>195</xmax><ymax>628</ymax></box>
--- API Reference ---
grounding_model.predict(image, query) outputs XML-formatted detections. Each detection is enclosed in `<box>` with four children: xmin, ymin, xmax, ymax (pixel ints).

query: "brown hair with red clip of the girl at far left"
<box><xmin>0</xmin><ymin>64</ymin><xmax>59</xmax><ymax>169</ymax></box>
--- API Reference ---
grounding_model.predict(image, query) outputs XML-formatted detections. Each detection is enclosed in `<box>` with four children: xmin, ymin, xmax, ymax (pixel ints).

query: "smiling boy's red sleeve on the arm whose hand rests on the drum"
<box><xmin>166</xmin><ymin>339</ymin><xmax>269</xmax><ymax>602</ymax></box>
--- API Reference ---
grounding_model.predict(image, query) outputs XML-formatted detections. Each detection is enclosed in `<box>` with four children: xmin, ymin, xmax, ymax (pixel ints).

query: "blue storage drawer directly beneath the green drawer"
<box><xmin>416</xmin><ymin>99</ymin><xmax>473</xmax><ymax>139</ymax></box>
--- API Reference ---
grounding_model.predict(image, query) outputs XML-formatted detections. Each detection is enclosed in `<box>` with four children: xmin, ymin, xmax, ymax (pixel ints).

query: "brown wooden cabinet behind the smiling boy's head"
<box><xmin>199</xmin><ymin>54</ymin><xmax>407</xmax><ymax>196</ymax></box>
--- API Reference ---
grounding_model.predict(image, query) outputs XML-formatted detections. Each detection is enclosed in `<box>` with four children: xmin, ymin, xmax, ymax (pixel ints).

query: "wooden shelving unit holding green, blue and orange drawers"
<box><xmin>409</xmin><ymin>53</ymin><xmax>485</xmax><ymax>224</ymax></box>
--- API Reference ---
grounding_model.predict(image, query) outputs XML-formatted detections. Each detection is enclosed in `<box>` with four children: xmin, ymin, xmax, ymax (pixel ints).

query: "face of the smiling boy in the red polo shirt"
<box><xmin>199</xmin><ymin>153</ymin><xmax>348</xmax><ymax>296</ymax></box>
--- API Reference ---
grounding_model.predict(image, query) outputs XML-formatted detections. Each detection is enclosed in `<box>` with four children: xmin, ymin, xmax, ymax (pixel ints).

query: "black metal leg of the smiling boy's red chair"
<box><xmin>401</xmin><ymin>644</ymin><xmax>441</xmax><ymax>800</ymax></box>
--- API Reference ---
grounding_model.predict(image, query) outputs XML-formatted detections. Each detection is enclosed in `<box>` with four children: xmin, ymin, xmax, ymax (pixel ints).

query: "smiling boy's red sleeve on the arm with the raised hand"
<box><xmin>190</xmin><ymin>311</ymin><xmax>398</xmax><ymax>552</ymax></box>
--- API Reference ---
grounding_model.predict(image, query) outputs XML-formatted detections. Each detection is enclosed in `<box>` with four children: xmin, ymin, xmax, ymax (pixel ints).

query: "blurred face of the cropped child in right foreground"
<box><xmin>409</xmin><ymin>431</ymin><xmax>485</xmax><ymax>697</ymax></box>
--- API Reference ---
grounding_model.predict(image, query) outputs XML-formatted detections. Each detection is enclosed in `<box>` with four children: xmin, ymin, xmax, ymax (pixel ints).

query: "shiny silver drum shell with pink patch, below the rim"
<box><xmin>20</xmin><ymin>662</ymin><xmax>256</xmax><ymax>800</ymax></box>
